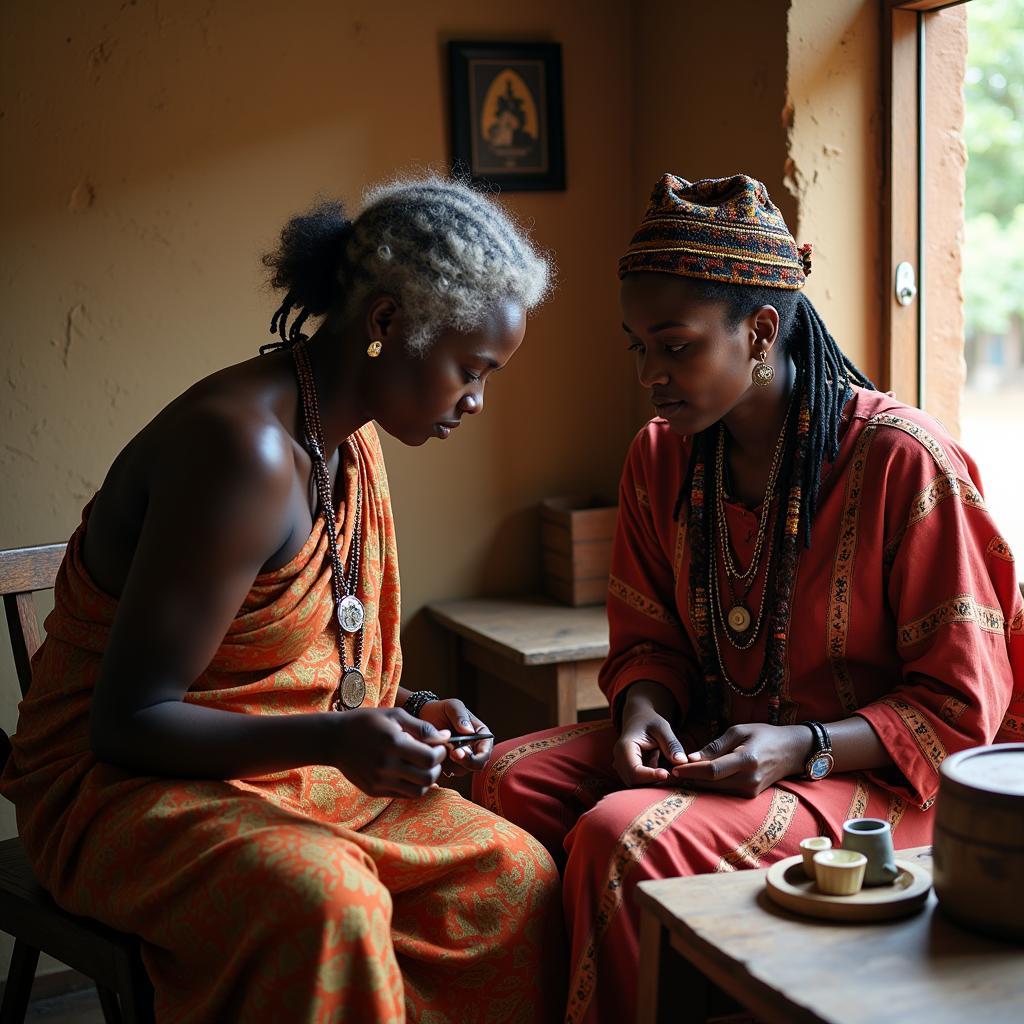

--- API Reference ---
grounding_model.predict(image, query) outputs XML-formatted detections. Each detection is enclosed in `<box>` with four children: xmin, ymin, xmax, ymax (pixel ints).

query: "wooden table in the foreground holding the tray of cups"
<box><xmin>637</xmin><ymin>847</ymin><xmax>1024</xmax><ymax>1024</ymax></box>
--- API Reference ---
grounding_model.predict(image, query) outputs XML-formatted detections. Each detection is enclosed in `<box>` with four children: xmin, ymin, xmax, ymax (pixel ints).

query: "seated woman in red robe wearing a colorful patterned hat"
<box><xmin>475</xmin><ymin>175</ymin><xmax>1024</xmax><ymax>1024</ymax></box>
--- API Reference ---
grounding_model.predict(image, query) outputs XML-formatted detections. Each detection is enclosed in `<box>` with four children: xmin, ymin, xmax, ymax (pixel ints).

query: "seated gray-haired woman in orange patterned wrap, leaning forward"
<box><xmin>2</xmin><ymin>178</ymin><xmax>562</xmax><ymax>1024</ymax></box>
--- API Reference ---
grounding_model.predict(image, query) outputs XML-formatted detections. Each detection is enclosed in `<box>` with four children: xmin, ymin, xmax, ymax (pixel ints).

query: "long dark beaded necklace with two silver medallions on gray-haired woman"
<box><xmin>292</xmin><ymin>341</ymin><xmax>367</xmax><ymax>711</ymax></box>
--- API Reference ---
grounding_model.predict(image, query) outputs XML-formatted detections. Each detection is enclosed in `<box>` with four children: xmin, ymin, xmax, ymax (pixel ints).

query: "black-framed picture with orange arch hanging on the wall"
<box><xmin>449</xmin><ymin>43</ymin><xmax>565</xmax><ymax>191</ymax></box>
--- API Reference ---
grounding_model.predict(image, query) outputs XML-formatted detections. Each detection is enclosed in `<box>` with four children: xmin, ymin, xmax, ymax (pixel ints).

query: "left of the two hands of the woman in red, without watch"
<box><xmin>612</xmin><ymin>681</ymin><xmax>686</xmax><ymax>786</ymax></box>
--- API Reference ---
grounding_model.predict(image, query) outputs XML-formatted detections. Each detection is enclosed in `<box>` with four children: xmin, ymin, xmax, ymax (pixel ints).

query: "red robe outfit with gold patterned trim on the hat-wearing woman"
<box><xmin>476</xmin><ymin>388</ymin><xmax>1024</xmax><ymax>1022</ymax></box>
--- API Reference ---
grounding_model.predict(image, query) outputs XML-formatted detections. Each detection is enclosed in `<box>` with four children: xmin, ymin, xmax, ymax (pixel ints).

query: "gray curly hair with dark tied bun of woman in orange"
<box><xmin>263</xmin><ymin>175</ymin><xmax>554</xmax><ymax>353</ymax></box>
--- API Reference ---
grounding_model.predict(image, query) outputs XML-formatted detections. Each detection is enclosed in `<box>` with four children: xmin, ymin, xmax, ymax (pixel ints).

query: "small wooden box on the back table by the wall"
<box><xmin>541</xmin><ymin>498</ymin><xmax>618</xmax><ymax>605</ymax></box>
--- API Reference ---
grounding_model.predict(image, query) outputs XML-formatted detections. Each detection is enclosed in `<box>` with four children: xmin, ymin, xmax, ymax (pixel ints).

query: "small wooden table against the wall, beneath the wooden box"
<box><xmin>427</xmin><ymin>597</ymin><xmax>608</xmax><ymax>728</ymax></box>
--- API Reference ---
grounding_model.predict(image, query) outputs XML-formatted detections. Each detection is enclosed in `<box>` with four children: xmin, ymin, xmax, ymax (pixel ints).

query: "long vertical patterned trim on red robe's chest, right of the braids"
<box><xmin>825</xmin><ymin>424</ymin><xmax>876</xmax><ymax>712</ymax></box>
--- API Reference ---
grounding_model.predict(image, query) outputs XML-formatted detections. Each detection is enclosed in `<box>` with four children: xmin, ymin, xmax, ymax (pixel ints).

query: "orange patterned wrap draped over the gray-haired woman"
<box><xmin>0</xmin><ymin>426</ymin><xmax>563</xmax><ymax>1024</ymax></box>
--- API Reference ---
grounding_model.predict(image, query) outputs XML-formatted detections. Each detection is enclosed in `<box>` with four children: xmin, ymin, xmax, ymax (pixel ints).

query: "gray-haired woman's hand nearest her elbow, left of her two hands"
<box><xmin>325</xmin><ymin>708</ymin><xmax>452</xmax><ymax>798</ymax></box>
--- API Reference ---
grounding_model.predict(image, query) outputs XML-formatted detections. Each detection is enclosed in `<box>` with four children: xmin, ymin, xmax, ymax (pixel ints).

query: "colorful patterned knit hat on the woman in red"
<box><xmin>618</xmin><ymin>174</ymin><xmax>811</xmax><ymax>289</ymax></box>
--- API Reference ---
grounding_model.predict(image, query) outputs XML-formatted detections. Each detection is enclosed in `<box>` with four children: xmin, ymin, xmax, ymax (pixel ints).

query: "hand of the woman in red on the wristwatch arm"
<box><xmin>671</xmin><ymin>722</ymin><xmax>811</xmax><ymax>799</ymax></box>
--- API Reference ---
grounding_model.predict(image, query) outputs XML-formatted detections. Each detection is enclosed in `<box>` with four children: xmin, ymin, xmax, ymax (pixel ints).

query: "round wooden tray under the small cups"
<box><xmin>765</xmin><ymin>854</ymin><xmax>932</xmax><ymax>921</ymax></box>
